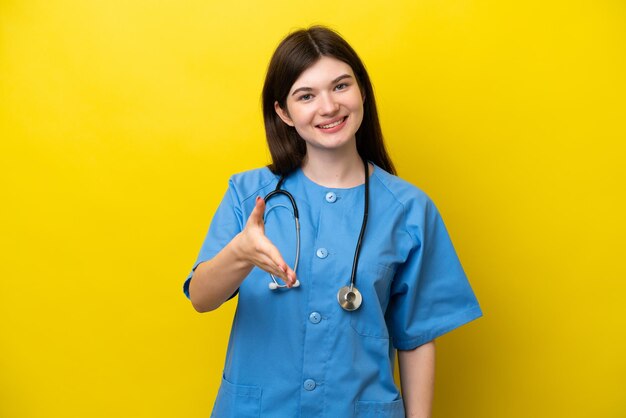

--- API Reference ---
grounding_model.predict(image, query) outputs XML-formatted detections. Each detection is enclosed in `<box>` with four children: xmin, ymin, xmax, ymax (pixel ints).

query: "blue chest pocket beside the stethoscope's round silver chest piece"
<box><xmin>349</xmin><ymin>260</ymin><xmax>394</xmax><ymax>338</ymax></box>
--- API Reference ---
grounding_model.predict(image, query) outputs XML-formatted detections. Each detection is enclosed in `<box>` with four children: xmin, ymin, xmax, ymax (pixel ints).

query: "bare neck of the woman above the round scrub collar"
<box><xmin>302</xmin><ymin>146</ymin><xmax>369</xmax><ymax>188</ymax></box>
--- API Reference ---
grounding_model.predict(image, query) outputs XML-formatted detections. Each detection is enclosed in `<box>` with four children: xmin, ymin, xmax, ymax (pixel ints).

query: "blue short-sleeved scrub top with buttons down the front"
<box><xmin>184</xmin><ymin>166</ymin><xmax>482</xmax><ymax>418</ymax></box>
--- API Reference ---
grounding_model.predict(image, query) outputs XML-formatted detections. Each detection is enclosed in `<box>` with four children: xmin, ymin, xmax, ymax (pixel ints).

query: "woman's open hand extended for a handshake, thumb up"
<box><xmin>238</xmin><ymin>197</ymin><xmax>296</xmax><ymax>287</ymax></box>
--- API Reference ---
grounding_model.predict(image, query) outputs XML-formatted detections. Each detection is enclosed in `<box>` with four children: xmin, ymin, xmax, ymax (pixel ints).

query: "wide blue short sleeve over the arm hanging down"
<box><xmin>387</xmin><ymin>200</ymin><xmax>482</xmax><ymax>350</ymax></box>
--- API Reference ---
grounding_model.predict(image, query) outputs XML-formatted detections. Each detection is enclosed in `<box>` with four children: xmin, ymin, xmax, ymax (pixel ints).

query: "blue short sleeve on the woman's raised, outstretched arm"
<box><xmin>183</xmin><ymin>179</ymin><xmax>243</xmax><ymax>298</ymax></box>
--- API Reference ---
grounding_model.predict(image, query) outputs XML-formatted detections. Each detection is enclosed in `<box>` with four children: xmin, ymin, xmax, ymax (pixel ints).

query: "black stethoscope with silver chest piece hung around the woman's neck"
<box><xmin>264</xmin><ymin>160</ymin><xmax>370</xmax><ymax>311</ymax></box>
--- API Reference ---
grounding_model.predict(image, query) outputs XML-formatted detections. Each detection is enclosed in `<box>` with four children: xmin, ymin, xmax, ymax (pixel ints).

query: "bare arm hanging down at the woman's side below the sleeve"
<box><xmin>398</xmin><ymin>340</ymin><xmax>435</xmax><ymax>418</ymax></box>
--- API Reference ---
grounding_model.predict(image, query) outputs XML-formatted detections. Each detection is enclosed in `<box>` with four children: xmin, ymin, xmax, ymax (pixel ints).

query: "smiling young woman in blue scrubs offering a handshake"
<box><xmin>184</xmin><ymin>26</ymin><xmax>481</xmax><ymax>418</ymax></box>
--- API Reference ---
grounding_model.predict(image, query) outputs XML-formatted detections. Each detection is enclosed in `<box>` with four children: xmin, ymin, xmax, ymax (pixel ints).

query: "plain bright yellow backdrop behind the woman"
<box><xmin>0</xmin><ymin>0</ymin><xmax>626</xmax><ymax>418</ymax></box>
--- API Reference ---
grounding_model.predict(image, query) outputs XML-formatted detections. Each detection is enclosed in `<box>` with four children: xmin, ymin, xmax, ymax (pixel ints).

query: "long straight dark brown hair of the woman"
<box><xmin>263</xmin><ymin>26</ymin><xmax>396</xmax><ymax>175</ymax></box>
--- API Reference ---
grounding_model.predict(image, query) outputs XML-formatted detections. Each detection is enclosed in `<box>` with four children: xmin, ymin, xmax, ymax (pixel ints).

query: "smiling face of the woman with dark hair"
<box><xmin>274</xmin><ymin>57</ymin><xmax>363</xmax><ymax>150</ymax></box>
